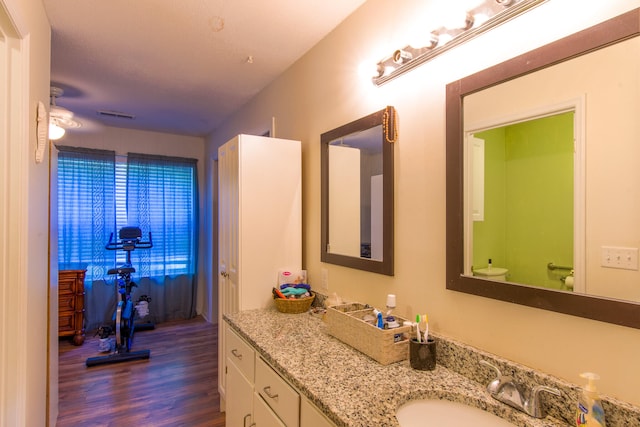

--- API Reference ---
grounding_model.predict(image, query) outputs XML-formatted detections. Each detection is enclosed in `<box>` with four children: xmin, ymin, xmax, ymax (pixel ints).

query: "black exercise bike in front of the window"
<box><xmin>86</xmin><ymin>227</ymin><xmax>154</xmax><ymax>366</ymax></box>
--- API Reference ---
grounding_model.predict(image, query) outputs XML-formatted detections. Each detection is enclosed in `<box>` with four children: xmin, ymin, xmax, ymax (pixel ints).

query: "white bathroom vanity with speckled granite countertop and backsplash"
<box><xmin>225</xmin><ymin>309</ymin><xmax>640</xmax><ymax>427</ymax></box>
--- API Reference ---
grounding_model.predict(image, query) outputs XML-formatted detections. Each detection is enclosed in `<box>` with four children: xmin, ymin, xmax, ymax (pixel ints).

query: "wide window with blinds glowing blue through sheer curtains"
<box><xmin>58</xmin><ymin>147</ymin><xmax>198</xmax><ymax>281</ymax></box>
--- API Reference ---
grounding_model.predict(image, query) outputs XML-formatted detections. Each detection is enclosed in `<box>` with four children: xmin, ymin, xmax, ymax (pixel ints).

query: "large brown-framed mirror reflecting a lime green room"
<box><xmin>446</xmin><ymin>9</ymin><xmax>640</xmax><ymax>328</ymax></box>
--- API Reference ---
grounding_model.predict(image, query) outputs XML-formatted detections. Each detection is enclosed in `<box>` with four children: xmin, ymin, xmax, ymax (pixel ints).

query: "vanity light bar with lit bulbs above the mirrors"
<box><xmin>372</xmin><ymin>0</ymin><xmax>547</xmax><ymax>86</ymax></box>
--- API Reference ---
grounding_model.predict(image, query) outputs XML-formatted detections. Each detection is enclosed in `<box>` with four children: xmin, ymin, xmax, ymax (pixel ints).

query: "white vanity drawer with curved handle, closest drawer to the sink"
<box><xmin>255</xmin><ymin>357</ymin><xmax>300</xmax><ymax>427</ymax></box>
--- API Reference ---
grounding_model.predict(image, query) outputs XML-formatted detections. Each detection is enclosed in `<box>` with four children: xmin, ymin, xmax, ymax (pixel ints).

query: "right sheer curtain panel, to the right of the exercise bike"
<box><xmin>127</xmin><ymin>153</ymin><xmax>198</xmax><ymax>322</ymax></box>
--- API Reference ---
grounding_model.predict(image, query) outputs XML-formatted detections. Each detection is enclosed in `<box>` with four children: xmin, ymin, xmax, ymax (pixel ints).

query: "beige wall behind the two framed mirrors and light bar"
<box><xmin>207</xmin><ymin>0</ymin><xmax>640</xmax><ymax>405</ymax></box>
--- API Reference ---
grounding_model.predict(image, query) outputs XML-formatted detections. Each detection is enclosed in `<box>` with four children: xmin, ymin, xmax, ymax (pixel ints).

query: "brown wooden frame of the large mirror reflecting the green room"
<box><xmin>446</xmin><ymin>9</ymin><xmax>640</xmax><ymax>329</ymax></box>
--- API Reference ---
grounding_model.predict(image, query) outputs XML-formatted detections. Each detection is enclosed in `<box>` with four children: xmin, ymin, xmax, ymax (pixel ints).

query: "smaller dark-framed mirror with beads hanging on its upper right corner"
<box><xmin>320</xmin><ymin>107</ymin><xmax>397</xmax><ymax>276</ymax></box>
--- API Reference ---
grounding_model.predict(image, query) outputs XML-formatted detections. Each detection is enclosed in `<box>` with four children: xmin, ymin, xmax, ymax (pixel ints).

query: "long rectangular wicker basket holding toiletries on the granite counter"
<box><xmin>325</xmin><ymin>303</ymin><xmax>411</xmax><ymax>365</ymax></box>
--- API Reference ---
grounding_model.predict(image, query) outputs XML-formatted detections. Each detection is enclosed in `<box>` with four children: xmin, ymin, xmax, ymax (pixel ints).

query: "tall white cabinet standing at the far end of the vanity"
<box><xmin>218</xmin><ymin>135</ymin><xmax>302</xmax><ymax>410</ymax></box>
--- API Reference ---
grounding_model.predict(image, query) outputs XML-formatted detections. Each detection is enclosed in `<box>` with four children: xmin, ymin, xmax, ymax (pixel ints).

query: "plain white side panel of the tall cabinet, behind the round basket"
<box><xmin>238</xmin><ymin>135</ymin><xmax>302</xmax><ymax>310</ymax></box>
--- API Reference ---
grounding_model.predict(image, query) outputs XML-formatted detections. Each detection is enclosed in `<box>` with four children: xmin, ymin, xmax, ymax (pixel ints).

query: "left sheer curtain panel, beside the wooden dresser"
<box><xmin>57</xmin><ymin>146</ymin><xmax>116</xmax><ymax>330</ymax></box>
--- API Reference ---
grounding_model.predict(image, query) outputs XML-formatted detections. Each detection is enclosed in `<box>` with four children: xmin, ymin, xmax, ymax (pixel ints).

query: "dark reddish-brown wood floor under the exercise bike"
<box><xmin>56</xmin><ymin>317</ymin><xmax>225</xmax><ymax>427</ymax></box>
